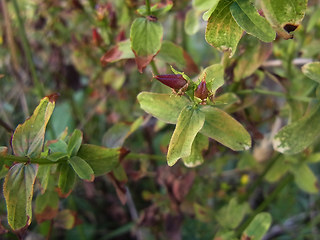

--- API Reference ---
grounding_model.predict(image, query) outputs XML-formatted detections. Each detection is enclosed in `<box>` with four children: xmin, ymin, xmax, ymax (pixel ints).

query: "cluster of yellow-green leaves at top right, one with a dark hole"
<box><xmin>205</xmin><ymin>0</ymin><xmax>307</xmax><ymax>57</ymax></box>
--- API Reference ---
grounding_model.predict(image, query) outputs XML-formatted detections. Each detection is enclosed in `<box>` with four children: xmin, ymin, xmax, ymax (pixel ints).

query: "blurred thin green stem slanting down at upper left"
<box><xmin>12</xmin><ymin>0</ymin><xmax>45</xmax><ymax>97</ymax></box>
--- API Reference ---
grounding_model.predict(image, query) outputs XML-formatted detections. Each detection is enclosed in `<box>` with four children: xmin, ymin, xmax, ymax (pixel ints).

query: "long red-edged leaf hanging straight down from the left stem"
<box><xmin>3</xmin><ymin>163</ymin><xmax>38</xmax><ymax>231</ymax></box>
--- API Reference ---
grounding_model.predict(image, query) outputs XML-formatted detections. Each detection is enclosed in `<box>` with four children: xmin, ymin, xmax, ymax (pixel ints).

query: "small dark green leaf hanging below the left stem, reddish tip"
<box><xmin>58</xmin><ymin>163</ymin><xmax>76</xmax><ymax>198</ymax></box>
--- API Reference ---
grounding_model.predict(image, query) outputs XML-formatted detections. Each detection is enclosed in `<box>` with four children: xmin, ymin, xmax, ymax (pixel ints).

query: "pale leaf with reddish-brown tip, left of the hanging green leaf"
<box><xmin>100</xmin><ymin>39</ymin><xmax>134</xmax><ymax>66</ymax></box>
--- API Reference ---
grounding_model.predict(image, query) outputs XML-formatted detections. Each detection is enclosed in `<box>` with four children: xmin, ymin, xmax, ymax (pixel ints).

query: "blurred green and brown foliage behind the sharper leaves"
<box><xmin>0</xmin><ymin>0</ymin><xmax>320</xmax><ymax>240</ymax></box>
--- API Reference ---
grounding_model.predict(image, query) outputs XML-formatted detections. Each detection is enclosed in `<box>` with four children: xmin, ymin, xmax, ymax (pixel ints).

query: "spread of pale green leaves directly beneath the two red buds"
<box><xmin>138</xmin><ymin>92</ymin><xmax>251</xmax><ymax>166</ymax></box>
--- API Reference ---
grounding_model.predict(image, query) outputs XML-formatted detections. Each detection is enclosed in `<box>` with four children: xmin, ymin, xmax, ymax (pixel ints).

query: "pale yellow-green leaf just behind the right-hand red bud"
<box><xmin>198</xmin><ymin>64</ymin><xmax>224</xmax><ymax>94</ymax></box>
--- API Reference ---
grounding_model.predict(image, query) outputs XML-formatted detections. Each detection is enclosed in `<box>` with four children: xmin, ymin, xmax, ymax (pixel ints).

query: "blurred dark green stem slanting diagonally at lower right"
<box><xmin>236</xmin><ymin>174</ymin><xmax>293</xmax><ymax>236</ymax></box>
